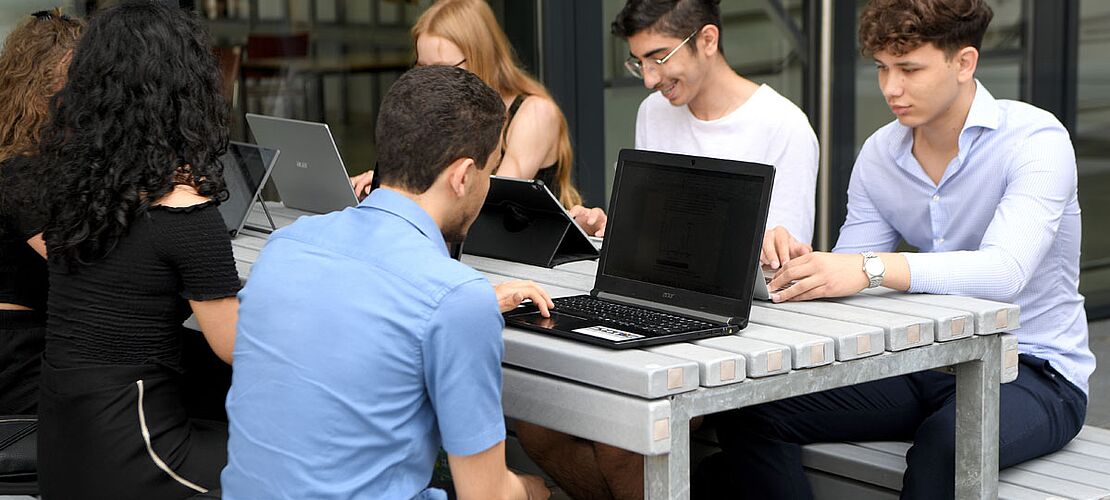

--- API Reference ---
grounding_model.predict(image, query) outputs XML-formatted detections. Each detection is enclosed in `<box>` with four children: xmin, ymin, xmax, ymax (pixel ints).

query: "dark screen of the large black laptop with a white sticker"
<box><xmin>602</xmin><ymin>160</ymin><xmax>768</xmax><ymax>299</ymax></box>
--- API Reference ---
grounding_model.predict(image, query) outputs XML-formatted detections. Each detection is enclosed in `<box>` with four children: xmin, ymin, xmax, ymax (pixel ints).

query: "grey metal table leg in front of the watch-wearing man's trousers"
<box><xmin>956</xmin><ymin>336</ymin><xmax>1002</xmax><ymax>499</ymax></box>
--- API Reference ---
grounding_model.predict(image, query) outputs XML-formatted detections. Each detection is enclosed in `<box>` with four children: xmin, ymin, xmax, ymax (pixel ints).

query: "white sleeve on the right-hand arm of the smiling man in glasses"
<box><xmin>767</xmin><ymin>113</ymin><xmax>819</xmax><ymax>243</ymax></box>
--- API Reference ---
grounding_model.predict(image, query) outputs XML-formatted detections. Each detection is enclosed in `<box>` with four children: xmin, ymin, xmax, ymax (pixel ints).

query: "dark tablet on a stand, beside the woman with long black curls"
<box><xmin>220</xmin><ymin>142</ymin><xmax>279</xmax><ymax>237</ymax></box>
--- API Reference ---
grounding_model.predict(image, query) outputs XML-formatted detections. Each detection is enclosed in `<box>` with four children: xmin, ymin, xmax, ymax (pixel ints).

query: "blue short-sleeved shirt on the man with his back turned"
<box><xmin>221</xmin><ymin>189</ymin><xmax>505</xmax><ymax>499</ymax></box>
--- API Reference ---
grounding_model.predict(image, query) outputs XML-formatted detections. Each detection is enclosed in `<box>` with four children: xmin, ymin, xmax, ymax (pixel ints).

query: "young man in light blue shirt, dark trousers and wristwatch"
<box><xmin>702</xmin><ymin>0</ymin><xmax>1094</xmax><ymax>498</ymax></box>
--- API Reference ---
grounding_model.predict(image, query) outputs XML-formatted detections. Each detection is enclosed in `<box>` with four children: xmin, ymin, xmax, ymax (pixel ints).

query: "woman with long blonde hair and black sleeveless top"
<box><xmin>354</xmin><ymin>0</ymin><xmax>605</xmax><ymax>236</ymax></box>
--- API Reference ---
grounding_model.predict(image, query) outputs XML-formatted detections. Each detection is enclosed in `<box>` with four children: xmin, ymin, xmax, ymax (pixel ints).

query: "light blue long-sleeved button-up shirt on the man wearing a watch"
<box><xmin>833</xmin><ymin>81</ymin><xmax>1094</xmax><ymax>393</ymax></box>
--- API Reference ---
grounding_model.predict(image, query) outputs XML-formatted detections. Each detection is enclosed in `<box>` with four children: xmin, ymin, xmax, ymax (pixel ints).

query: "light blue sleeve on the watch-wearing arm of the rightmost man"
<box><xmin>906</xmin><ymin>124</ymin><xmax>1078</xmax><ymax>302</ymax></box>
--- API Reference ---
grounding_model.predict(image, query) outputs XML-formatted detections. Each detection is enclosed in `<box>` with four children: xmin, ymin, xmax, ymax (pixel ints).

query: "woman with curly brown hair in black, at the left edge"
<box><xmin>0</xmin><ymin>9</ymin><xmax>84</xmax><ymax>414</ymax></box>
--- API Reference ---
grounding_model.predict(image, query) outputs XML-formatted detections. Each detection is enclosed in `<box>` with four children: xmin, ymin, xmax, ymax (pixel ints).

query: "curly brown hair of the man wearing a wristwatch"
<box><xmin>859</xmin><ymin>0</ymin><xmax>995</xmax><ymax>57</ymax></box>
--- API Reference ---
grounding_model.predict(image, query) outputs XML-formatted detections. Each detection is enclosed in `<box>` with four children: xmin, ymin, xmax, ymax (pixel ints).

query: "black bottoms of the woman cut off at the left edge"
<box><xmin>0</xmin><ymin>311</ymin><xmax>47</xmax><ymax>416</ymax></box>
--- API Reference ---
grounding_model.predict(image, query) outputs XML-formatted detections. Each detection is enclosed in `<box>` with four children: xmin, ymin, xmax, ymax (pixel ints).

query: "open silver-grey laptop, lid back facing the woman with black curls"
<box><xmin>246</xmin><ymin>113</ymin><xmax>359</xmax><ymax>213</ymax></box>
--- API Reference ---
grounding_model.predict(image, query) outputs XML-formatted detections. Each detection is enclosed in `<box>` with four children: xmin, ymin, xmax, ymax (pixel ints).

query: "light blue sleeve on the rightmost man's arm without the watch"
<box><xmin>833</xmin><ymin>139</ymin><xmax>901</xmax><ymax>253</ymax></box>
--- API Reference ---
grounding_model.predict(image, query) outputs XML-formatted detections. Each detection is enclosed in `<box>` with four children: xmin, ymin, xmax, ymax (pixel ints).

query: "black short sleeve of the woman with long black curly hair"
<box><xmin>160</xmin><ymin>203</ymin><xmax>240</xmax><ymax>300</ymax></box>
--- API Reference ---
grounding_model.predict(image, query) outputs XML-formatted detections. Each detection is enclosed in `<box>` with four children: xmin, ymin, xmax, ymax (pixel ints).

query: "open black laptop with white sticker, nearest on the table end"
<box><xmin>505</xmin><ymin>150</ymin><xmax>775</xmax><ymax>349</ymax></box>
